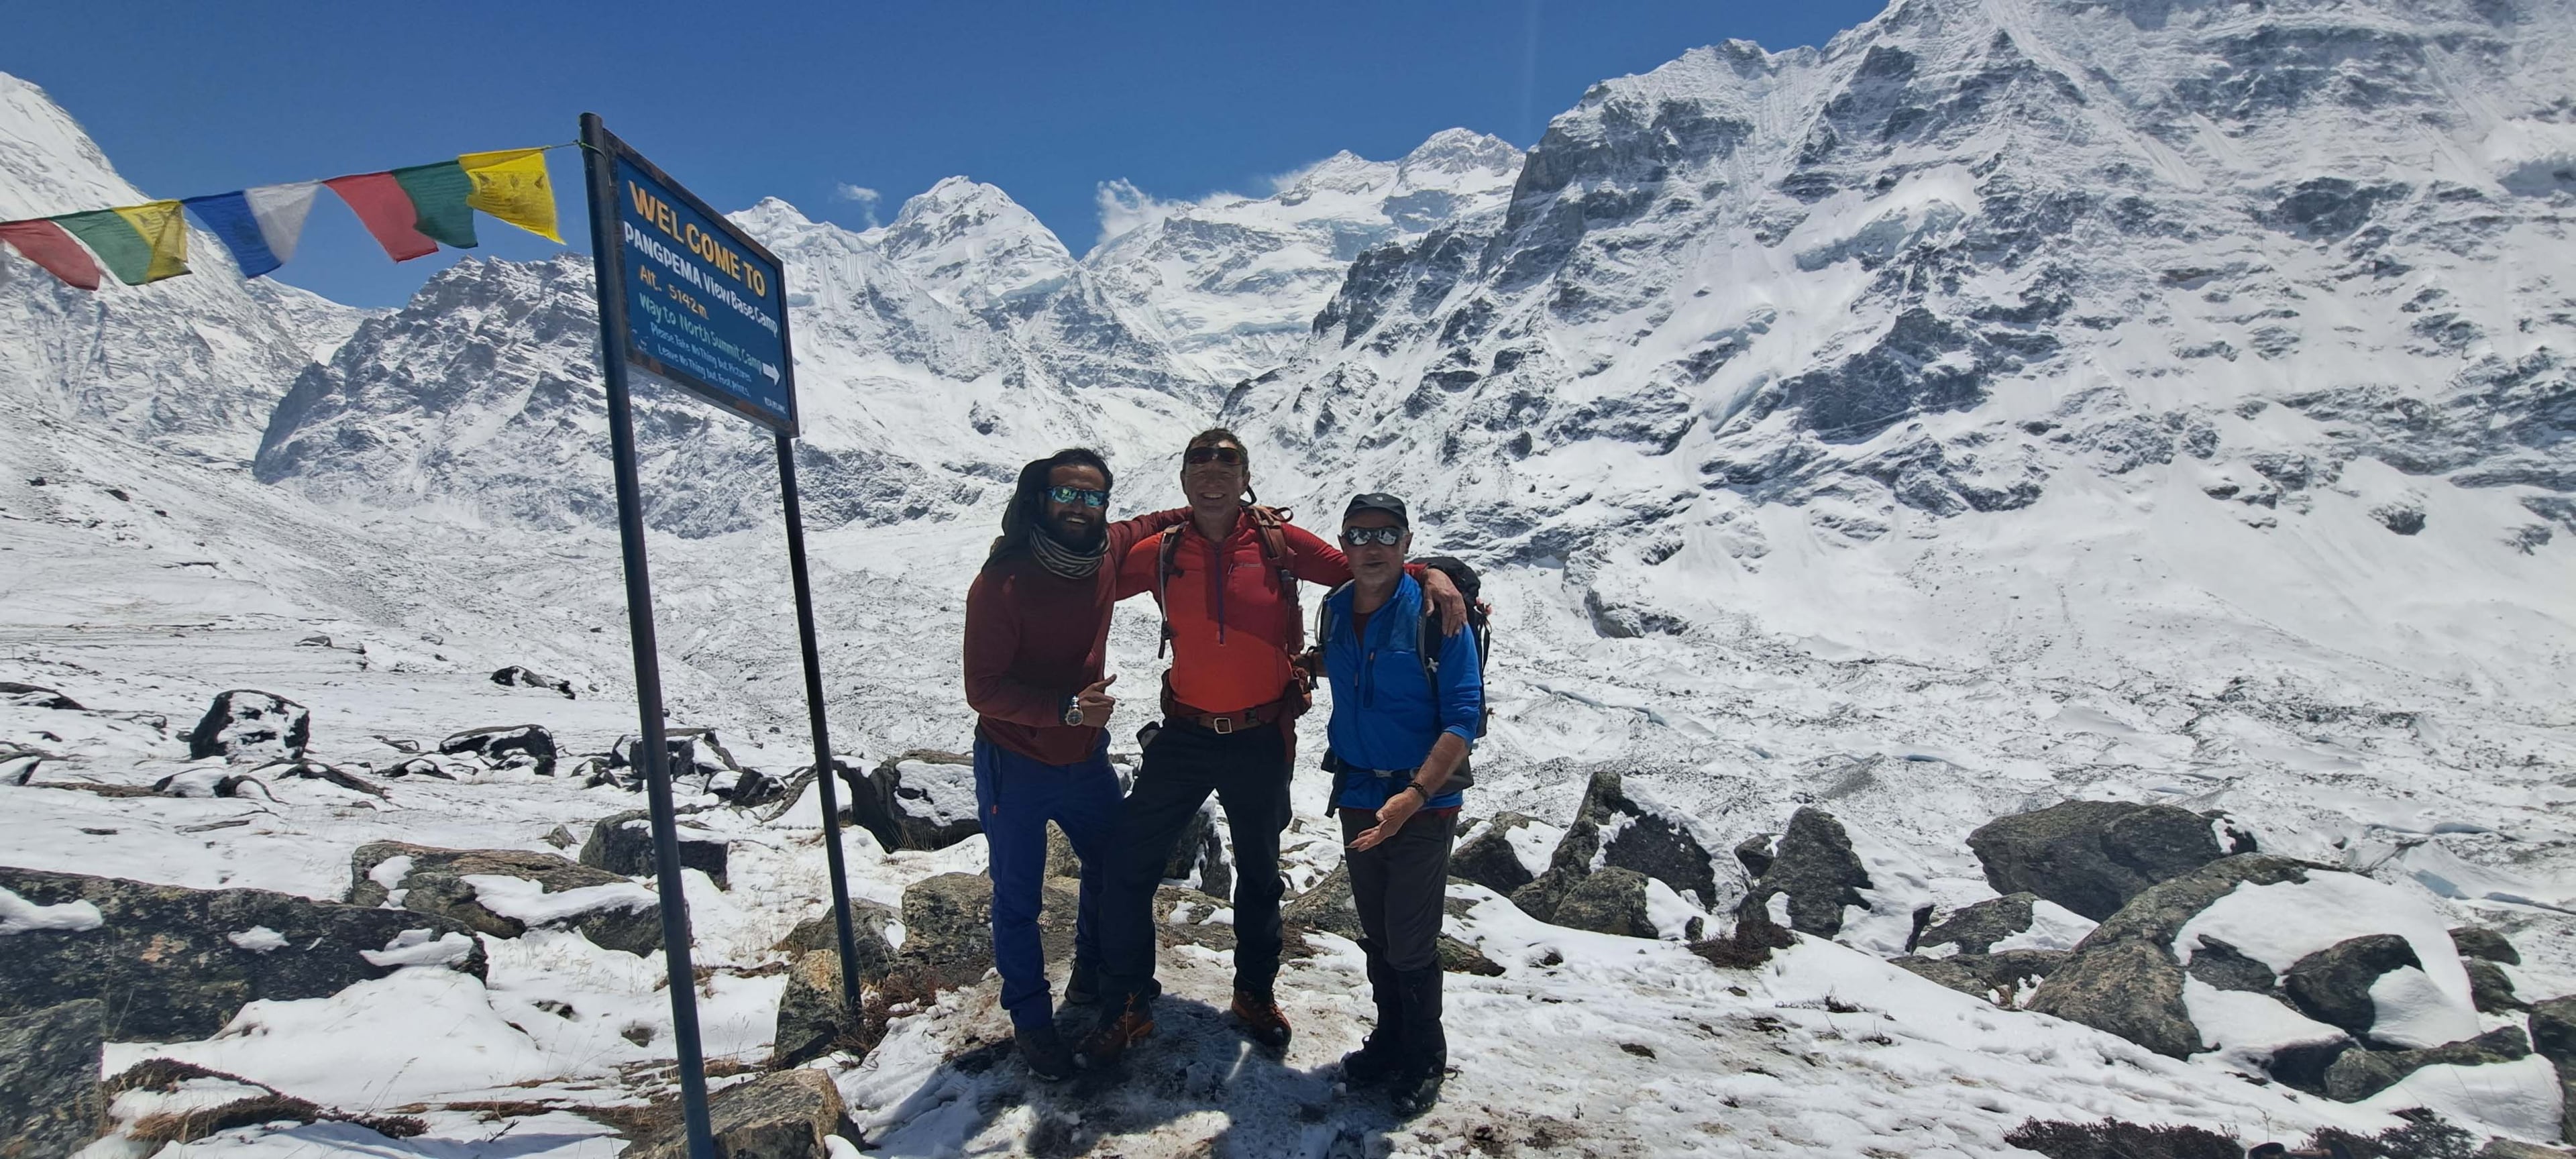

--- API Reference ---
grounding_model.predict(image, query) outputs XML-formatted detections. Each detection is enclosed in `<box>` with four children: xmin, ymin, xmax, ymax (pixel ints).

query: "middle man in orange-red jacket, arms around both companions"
<box><xmin>1077</xmin><ymin>427</ymin><xmax>1466</xmax><ymax>1066</ymax></box>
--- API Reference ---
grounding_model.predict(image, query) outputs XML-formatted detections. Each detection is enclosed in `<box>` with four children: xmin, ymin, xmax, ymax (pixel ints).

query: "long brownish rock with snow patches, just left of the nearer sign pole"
<box><xmin>347</xmin><ymin>842</ymin><xmax>662</xmax><ymax>956</ymax></box>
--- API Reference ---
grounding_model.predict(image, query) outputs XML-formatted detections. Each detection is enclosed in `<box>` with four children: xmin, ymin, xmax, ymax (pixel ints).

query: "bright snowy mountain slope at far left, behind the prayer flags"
<box><xmin>0</xmin><ymin>72</ymin><xmax>312</xmax><ymax>461</ymax></box>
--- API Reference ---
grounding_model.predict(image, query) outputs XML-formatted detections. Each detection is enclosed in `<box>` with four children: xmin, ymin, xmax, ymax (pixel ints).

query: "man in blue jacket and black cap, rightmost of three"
<box><xmin>1319</xmin><ymin>494</ymin><xmax>1484</xmax><ymax>1115</ymax></box>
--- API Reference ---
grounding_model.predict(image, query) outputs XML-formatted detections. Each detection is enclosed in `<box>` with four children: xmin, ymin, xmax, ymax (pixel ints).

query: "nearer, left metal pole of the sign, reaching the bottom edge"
<box><xmin>582</xmin><ymin>113</ymin><xmax>716</xmax><ymax>1159</ymax></box>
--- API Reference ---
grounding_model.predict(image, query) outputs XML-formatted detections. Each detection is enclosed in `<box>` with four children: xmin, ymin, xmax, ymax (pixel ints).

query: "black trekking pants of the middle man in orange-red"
<box><xmin>1100</xmin><ymin>721</ymin><xmax>1288</xmax><ymax>999</ymax></box>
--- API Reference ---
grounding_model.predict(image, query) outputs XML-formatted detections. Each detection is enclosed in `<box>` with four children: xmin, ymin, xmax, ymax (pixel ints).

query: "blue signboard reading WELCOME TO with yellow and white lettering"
<box><xmin>608</xmin><ymin>137</ymin><xmax>796</xmax><ymax>435</ymax></box>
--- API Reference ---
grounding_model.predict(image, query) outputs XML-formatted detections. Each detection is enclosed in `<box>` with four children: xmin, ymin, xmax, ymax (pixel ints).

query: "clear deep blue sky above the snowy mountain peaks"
<box><xmin>0</xmin><ymin>0</ymin><xmax>1880</xmax><ymax>307</ymax></box>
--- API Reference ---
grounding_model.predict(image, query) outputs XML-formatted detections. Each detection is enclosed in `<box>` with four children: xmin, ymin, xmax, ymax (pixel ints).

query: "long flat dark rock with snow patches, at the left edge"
<box><xmin>0</xmin><ymin>868</ymin><xmax>484</xmax><ymax>1040</ymax></box>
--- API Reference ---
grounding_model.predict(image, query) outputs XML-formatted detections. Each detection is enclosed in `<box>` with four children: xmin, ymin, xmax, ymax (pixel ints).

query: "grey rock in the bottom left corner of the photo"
<box><xmin>0</xmin><ymin>999</ymin><xmax>108</xmax><ymax>1159</ymax></box>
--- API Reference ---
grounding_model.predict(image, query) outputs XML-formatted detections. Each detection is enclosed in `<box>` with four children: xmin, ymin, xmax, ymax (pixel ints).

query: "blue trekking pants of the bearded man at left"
<box><xmin>974</xmin><ymin>732</ymin><xmax>1118</xmax><ymax>1025</ymax></box>
